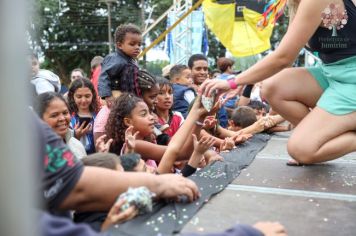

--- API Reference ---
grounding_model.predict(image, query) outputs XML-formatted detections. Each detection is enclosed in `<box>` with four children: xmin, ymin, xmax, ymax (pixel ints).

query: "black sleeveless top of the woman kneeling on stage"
<box><xmin>308</xmin><ymin>0</ymin><xmax>356</xmax><ymax>63</ymax></box>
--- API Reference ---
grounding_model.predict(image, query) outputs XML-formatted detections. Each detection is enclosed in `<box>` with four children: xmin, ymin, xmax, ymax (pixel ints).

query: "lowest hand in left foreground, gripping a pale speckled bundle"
<box><xmin>101</xmin><ymin>199</ymin><xmax>138</xmax><ymax>231</ymax></box>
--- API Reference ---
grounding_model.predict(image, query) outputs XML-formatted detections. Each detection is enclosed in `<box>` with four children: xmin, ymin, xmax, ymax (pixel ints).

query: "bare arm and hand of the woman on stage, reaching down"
<box><xmin>200</xmin><ymin>0</ymin><xmax>326</xmax><ymax>96</ymax></box>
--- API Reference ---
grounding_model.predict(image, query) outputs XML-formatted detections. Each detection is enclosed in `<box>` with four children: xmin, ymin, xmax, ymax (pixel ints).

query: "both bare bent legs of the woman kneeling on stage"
<box><xmin>262</xmin><ymin>68</ymin><xmax>356</xmax><ymax>164</ymax></box>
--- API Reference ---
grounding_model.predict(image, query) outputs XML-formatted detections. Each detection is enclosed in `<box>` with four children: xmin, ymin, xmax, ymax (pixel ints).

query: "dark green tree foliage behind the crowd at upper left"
<box><xmin>28</xmin><ymin>0</ymin><xmax>171</xmax><ymax>85</ymax></box>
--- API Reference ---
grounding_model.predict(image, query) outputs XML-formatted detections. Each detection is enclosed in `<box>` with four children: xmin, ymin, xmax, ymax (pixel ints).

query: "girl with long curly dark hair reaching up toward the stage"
<box><xmin>111</xmin><ymin>91</ymin><xmax>221</xmax><ymax>174</ymax></box>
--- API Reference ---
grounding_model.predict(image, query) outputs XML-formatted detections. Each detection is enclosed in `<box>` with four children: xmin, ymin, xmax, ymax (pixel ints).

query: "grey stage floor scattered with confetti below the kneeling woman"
<box><xmin>183</xmin><ymin>133</ymin><xmax>356</xmax><ymax>236</ymax></box>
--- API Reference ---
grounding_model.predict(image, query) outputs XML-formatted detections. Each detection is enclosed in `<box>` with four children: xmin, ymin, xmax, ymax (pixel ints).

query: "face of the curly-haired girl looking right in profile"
<box><xmin>125</xmin><ymin>102</ymin><xmax>155</xmax><ymax>138</ymax></box>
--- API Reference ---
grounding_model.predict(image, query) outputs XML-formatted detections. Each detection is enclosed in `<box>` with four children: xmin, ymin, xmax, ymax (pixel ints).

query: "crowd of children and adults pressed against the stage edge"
<box><xmin>31</xmin><ymin>24</ymin><xmax>290</xmax><ymax>235</ymax></box>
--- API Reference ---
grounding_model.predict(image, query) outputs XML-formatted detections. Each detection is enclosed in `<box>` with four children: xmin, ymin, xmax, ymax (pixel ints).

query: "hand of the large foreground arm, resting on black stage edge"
<box><xmin>155</xmin><ymin>174</ymin><xmax>200</xmax><ymax>202</ymax></box>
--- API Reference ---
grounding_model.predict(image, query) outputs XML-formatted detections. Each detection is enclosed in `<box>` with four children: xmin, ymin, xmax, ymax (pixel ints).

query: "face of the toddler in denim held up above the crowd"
<box><xmin>117</xmin><ymin>32</ymin><xmax>142</xmax><ymax>58</ymax></box>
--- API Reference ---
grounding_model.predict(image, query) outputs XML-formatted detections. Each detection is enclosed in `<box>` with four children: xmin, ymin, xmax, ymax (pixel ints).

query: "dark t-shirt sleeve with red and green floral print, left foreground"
<box><xmin>35</xmin><ymin>117</ymin><xmax>84</xmax><ymax>214</ymax></box>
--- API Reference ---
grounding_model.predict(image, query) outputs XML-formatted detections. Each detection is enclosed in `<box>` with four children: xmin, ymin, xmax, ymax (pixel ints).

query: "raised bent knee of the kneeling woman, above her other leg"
<box><xmin>262</xmin><ymin>68</ymin><xmax>323</xmax><ymax>126</ymax></box>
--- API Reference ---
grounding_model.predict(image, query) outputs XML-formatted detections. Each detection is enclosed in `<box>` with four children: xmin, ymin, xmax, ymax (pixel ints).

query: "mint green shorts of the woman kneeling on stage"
<box><xmin>306</xmin><ymin>56</ymin><xmax>356</xmax><ymax>115</ymax></box>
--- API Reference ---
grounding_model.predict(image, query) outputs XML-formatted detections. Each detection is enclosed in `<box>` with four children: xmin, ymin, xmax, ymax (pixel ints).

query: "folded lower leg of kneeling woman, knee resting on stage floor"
<box><xmin>288</xmin><ymin>107</ymin><xmax>356</xmax><ymax>164</ymax></box>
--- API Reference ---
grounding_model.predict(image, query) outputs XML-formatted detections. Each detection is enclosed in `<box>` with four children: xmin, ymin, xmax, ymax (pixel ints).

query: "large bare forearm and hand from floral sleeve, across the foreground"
<box><xmin>60</xmin><ymin>167</ymin><xmax>199</xmax><ymax>211</ymax></box>
